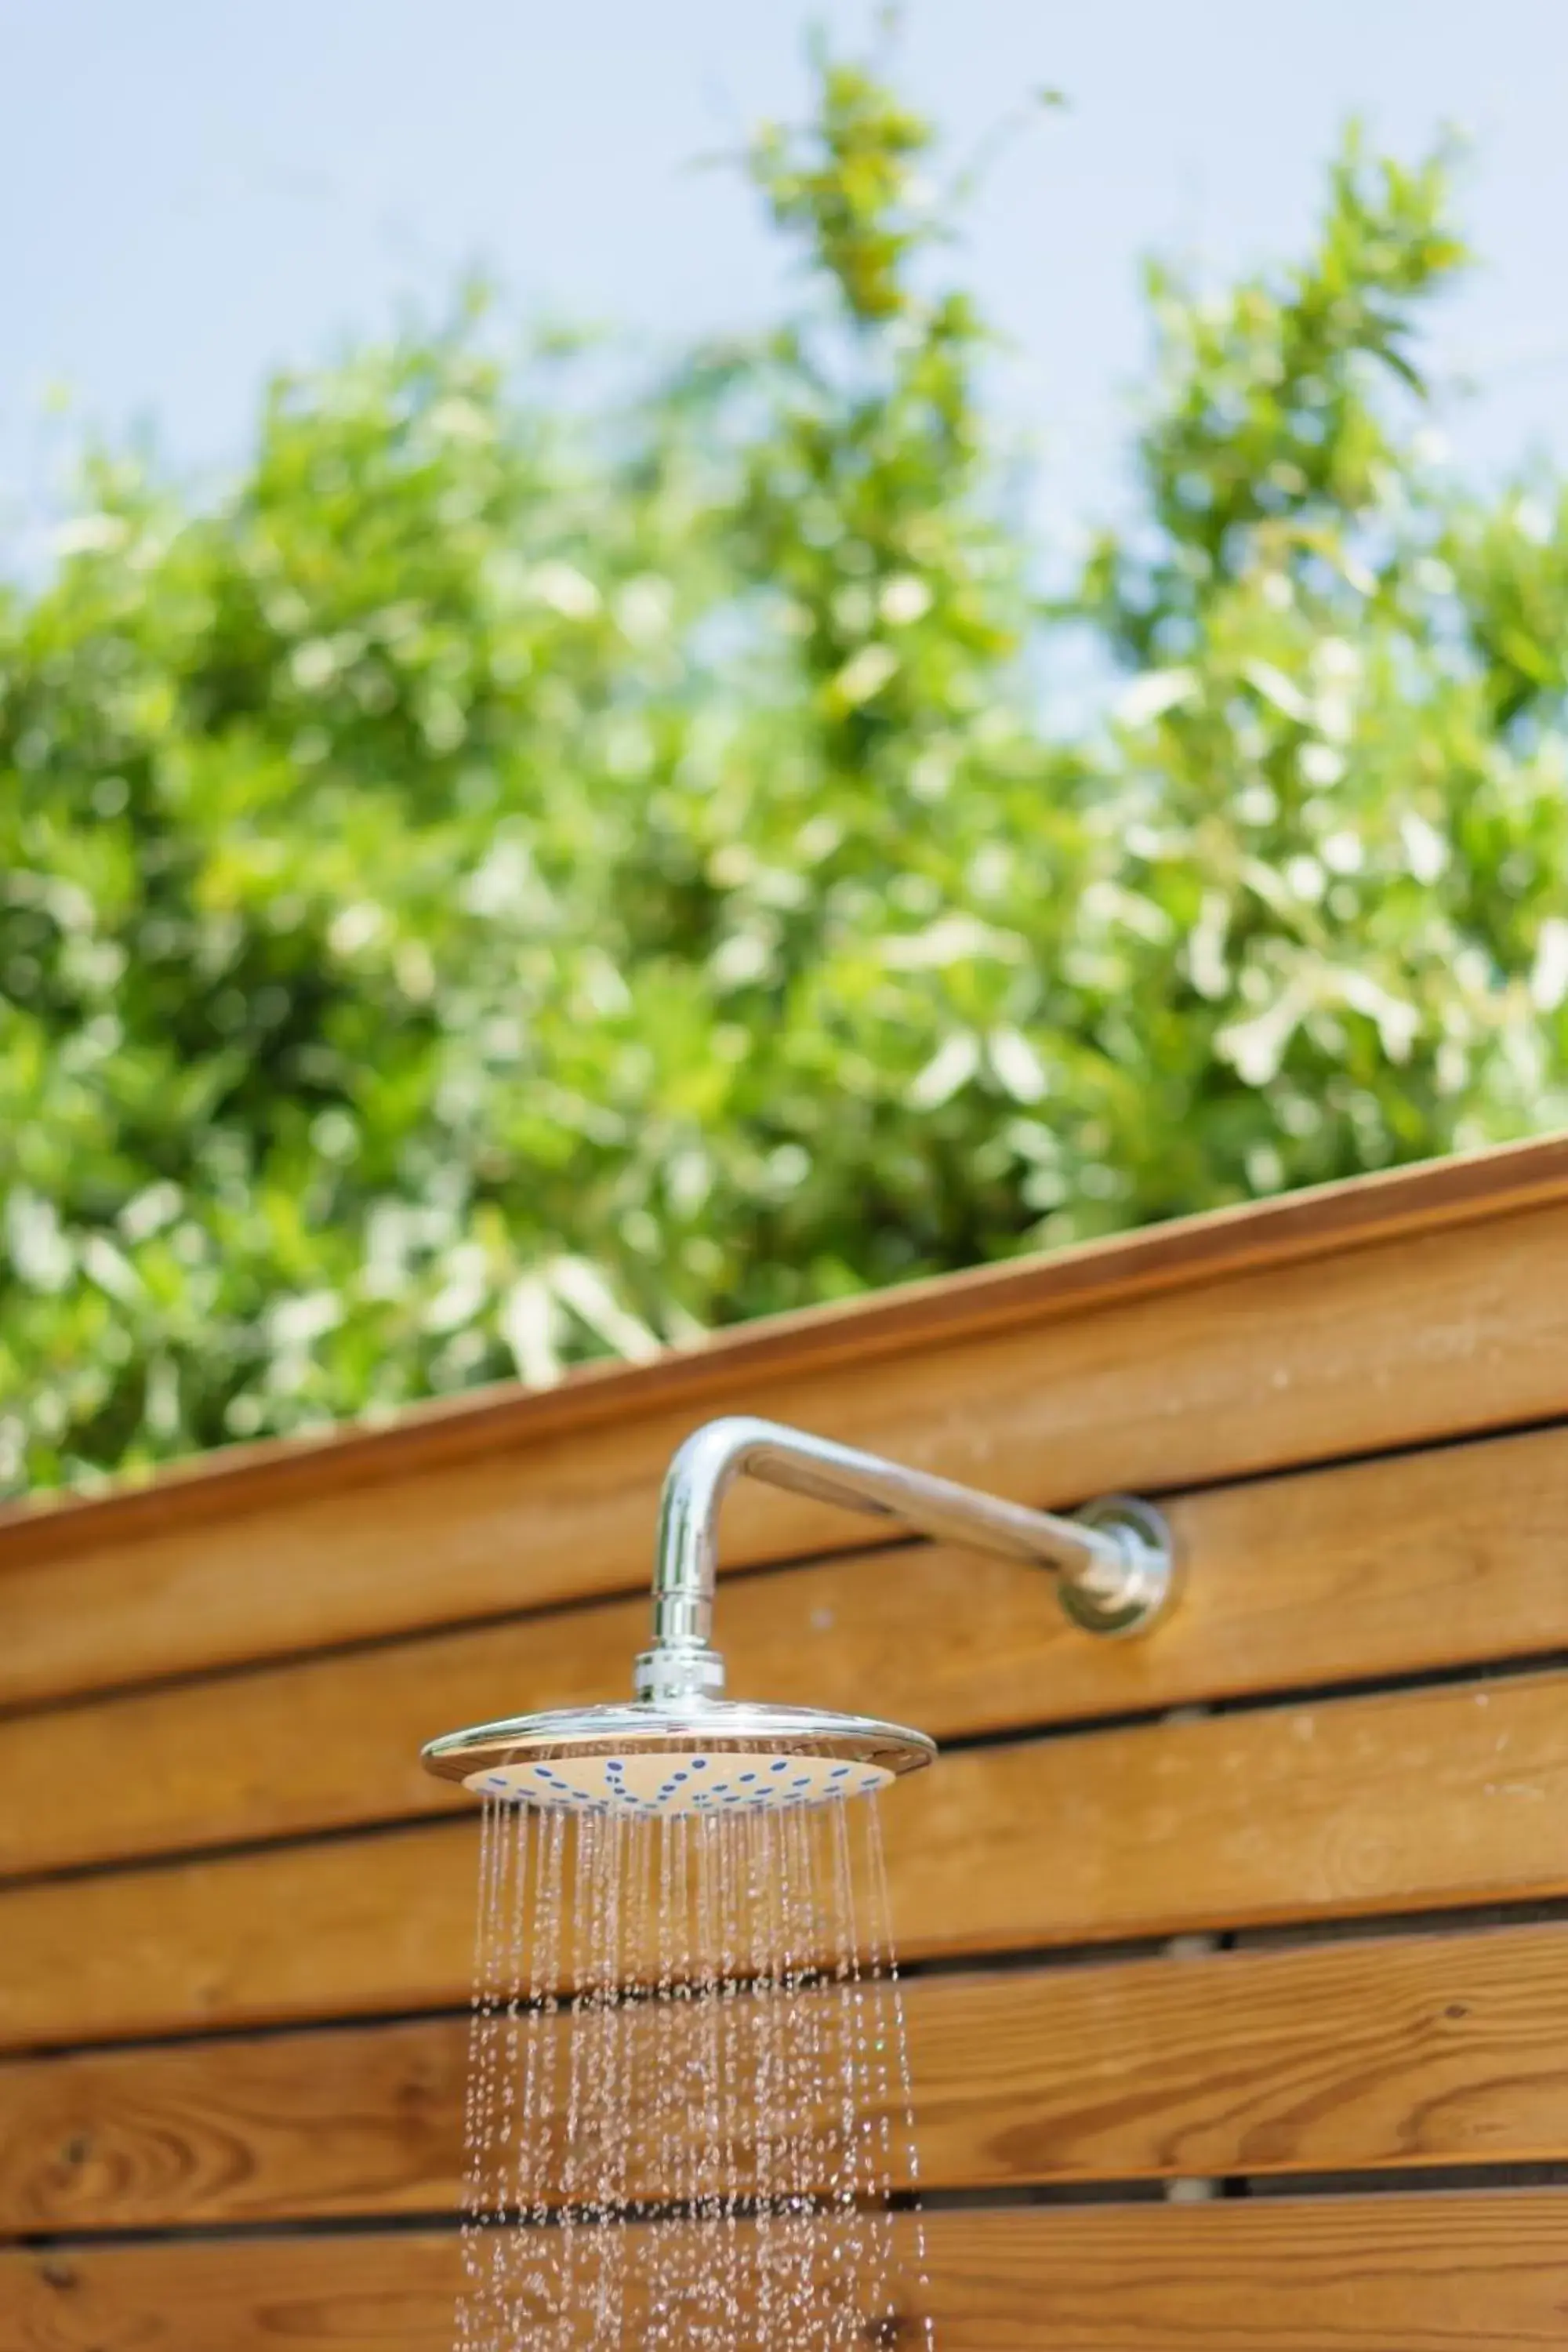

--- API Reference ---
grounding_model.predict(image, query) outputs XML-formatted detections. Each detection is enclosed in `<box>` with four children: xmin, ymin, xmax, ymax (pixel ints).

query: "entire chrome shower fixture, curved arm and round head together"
<box><xmin>423</xmin><ymin>1418</ymin><xmax>1175</xmax><ymax>1818</ymax></box>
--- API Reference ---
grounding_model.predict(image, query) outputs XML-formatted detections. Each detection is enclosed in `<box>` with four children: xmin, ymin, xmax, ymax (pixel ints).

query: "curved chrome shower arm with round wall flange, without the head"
<box><xmin>637</xmin><ymin>1414</ymin><xmax>1175</xmax><ymax>1700</ymax></box>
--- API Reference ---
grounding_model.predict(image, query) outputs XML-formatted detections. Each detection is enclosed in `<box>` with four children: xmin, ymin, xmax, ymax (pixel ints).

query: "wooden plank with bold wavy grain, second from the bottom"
<box><xmin>0</xmin><ymin>1926</ymin><xmax>1568</xmax><ymax>2237</ymax></box>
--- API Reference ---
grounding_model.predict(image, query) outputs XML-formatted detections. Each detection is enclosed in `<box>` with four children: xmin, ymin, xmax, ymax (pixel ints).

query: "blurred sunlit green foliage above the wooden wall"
<box><xmin>0</xmin><ymin>59</ymin><xmax>1568</xmax><ymax>1484</ymax></box>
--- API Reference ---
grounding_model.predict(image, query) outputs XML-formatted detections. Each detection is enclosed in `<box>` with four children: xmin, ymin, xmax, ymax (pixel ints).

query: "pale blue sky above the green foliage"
<box><xmin>0</xmin><ymin>0</ymin><xmax>1568</xmax><ymax>560</ymax></box>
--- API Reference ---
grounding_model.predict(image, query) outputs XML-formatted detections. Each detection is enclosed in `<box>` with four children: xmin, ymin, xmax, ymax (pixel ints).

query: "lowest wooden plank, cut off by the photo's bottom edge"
<box><xmin>0</xmin><ymin>2190</ymin><xmax>1568</xmax><ymax>2352</ymax></box>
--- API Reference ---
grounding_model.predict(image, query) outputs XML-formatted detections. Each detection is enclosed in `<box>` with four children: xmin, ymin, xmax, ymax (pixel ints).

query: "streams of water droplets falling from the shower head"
<box><xmin>456</xmin><ymin>1797</ymin><xmax>926</xmax><ymax>2352</ymax></box>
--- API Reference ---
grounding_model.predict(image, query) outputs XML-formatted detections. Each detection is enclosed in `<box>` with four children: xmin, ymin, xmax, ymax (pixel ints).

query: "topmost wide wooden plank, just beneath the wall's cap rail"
<box><xmin>0</xmin><ymin>1160</ymin><xmax>1568</xmax><ymax>1703</ymax></box>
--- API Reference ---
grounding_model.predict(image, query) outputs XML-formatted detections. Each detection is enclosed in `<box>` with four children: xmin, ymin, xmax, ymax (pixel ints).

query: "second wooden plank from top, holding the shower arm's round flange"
<box><xmin>0</xmin><ymin>1402</ymin><xmax>1568</xmax><ymax>1875</ymax></box>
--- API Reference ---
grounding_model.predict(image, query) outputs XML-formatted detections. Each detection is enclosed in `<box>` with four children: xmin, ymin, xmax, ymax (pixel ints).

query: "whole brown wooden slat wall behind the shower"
<box><xmin>0</xmin><ymin>1143</ymin><xmax>1568</xmax><ymax>2352</ymax></box>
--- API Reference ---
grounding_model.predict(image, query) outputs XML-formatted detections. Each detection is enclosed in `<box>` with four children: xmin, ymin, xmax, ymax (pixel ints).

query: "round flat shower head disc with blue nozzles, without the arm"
<box><xmin>423</xmin><ymin>1700</ymin><xmax>935</xmax><ymax>1820</ymax></box>
